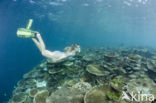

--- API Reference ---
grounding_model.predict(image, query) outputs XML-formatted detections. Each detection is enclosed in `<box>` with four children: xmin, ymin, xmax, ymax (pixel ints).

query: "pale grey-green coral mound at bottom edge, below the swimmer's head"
<box><xmin>46</xmin><ymin>82</ymin><xmax>91</xmax><ymax>103</ymax></box>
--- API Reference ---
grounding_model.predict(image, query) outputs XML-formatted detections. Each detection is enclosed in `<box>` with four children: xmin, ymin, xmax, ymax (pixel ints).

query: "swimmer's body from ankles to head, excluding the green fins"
<box><xmin>32</xmin><ymin>33</ymin><xmax>80</xmax><ymax>63</ymax></box>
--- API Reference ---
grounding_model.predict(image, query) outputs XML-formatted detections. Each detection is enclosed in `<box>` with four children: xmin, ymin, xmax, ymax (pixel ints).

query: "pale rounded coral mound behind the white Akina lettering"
<box><xmin>125</xmin><ymin>76</ymin><xmax>156</xmax><ymax>103</ymax></box>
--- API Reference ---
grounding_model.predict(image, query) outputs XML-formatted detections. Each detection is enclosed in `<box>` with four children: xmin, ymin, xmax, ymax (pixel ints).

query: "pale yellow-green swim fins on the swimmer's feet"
<box><xmin>17</xmin><ymin>19</ymin><xmax>37</xmax><ymax>38</ymax></box>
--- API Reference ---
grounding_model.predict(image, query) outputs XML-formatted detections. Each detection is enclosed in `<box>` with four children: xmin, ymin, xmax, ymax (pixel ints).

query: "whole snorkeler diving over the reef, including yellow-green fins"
<box><xmin>17</xmin><ymin>19</ymin><xmax>80</xmax><ymax>63</ymax></box>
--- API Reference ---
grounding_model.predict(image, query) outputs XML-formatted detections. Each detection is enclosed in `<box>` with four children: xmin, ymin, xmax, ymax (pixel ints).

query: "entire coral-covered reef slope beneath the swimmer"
<box><xmin>8</xmin><ymin>47</ymin><xmax>156</xmax><ymax>103</ymax></box>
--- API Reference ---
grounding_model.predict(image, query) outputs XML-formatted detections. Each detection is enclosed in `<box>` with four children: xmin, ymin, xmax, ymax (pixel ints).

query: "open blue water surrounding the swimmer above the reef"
<box><xmin>0</xmin><ymin>0</ymin><xmax>156</xmax><ymax>103</ymax></box>
